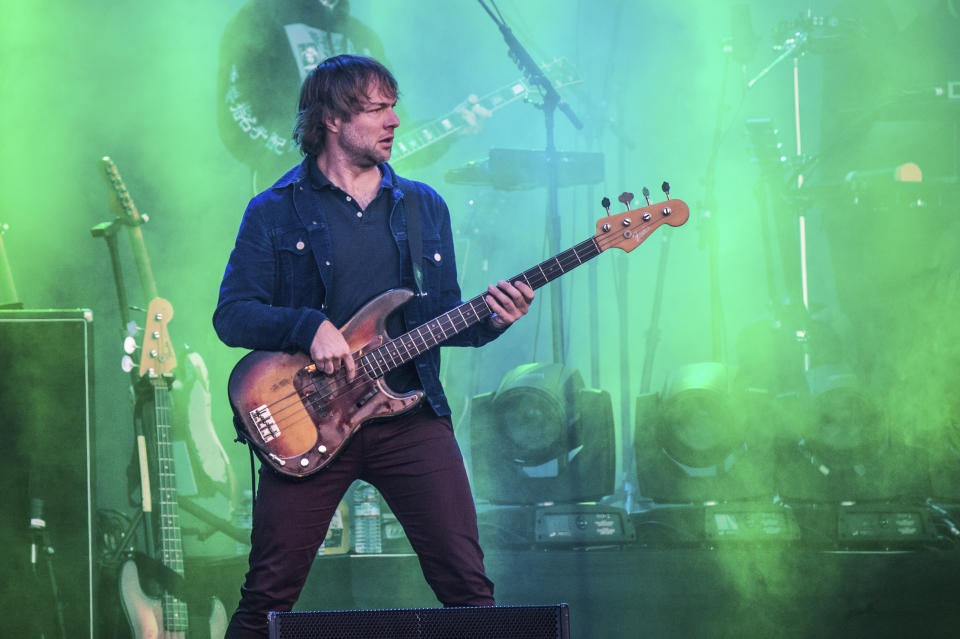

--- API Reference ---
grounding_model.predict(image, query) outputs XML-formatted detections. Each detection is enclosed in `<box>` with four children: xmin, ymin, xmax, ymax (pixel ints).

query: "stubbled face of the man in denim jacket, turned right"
<box><xmin>334</xmin><ymin>88</ymin><xmax>400</xmax><ymax>168</ymax></box>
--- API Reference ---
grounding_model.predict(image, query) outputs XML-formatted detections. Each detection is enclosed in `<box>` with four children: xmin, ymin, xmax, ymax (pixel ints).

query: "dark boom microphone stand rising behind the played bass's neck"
<box><xmin>477</xmin><ymin>0</ymin><xmax>583</xmax><ymax>364</ymax></box>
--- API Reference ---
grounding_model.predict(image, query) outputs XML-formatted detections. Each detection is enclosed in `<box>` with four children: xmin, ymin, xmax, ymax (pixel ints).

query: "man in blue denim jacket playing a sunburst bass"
<box><xmin>213</xmin><ymin>55</ymin><xmax>534</xmax><ymax>639</ymax></box>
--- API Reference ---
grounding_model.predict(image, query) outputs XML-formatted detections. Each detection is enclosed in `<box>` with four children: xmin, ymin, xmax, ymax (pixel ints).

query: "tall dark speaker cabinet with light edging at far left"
<box><xmin>0</xmin><ymin>309</ymin><xmax>96</xmax><ymax>639</ymax></box>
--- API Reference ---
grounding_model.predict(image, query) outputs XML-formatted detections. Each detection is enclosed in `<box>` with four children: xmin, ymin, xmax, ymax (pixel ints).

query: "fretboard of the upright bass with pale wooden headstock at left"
<box><xmin>151</xmin><ymin>377</ymin><xmax>188</xmax><ymax>632</ymax></box>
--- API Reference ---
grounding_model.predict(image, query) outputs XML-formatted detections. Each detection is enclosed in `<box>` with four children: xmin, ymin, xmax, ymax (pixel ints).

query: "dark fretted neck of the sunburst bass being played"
<box><xmin>360</xmin><ymin>237</ymin><xmax>602</xmax><ymax>377</ymax></box>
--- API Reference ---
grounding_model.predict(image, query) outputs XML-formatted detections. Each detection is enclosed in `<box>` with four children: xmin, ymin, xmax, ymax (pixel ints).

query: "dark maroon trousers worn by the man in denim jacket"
<box><xmin>226</xmin><ymin>407</ymin><xmax>494</xmax><ymax>639</ymax></box>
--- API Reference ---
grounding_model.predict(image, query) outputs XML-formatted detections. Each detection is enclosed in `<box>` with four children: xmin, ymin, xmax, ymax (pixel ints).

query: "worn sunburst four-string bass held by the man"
<box><xmin>228</xmin><ymin>199</ymin><xmax>690</xmax><ymax>477</ymax></box>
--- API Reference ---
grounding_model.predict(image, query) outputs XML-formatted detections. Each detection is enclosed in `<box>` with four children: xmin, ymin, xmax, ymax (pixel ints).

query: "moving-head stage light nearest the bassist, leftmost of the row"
<box><xmin>470</xmin><ymin>363</ymin><xmax>616</xmax><ymax>504</ymax></box>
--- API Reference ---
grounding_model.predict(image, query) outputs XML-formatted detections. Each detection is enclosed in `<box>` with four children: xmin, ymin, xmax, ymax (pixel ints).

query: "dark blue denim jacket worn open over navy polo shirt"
<box><xmin>213</xmin><ymin>157</ymin><xmax>500</xmax><ymax>415</ymax></box>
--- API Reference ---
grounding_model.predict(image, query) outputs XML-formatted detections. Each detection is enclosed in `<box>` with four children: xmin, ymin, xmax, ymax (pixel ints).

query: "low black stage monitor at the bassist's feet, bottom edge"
<box><xmin>269</xmin><ymin>604</ymin><xmax>570</xmax><ymax>639</ymax></box>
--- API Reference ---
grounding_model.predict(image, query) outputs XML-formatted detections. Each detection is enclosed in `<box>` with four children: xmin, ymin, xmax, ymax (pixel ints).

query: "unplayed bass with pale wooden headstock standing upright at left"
<box><xmin>120</xmin><ymin>297</ymin><xmax>227</xmax><ymax>639</ymax></box>
